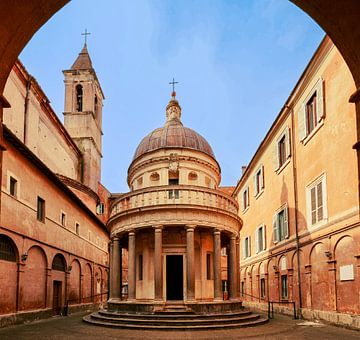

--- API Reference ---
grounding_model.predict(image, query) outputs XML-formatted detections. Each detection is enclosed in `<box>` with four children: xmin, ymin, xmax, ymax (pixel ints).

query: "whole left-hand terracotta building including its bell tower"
<box><xmin>0</xmin><ymin>46</ymin><xmax>110</xmax><ymax>326</ymax></box>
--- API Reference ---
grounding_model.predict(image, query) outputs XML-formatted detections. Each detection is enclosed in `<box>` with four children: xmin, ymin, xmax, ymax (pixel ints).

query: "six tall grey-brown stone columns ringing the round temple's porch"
<box><xmin>110</xmin><ymin>225</ymin><xmax>239</xmax><ymax>302</ymax></box>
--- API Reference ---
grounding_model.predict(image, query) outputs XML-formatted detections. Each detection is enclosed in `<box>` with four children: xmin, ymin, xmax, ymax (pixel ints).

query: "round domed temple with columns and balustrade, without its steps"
<box><xmin>108</xmin><ymin>92</ymin><xmax>241</xmax><ymax>310</ymax></box>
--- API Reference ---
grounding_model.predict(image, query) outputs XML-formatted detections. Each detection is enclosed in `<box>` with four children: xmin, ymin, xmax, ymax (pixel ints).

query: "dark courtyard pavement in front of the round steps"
<box><xmin>0</xmin><ymin>313</ymin><xmax>360</xmax><ymax>340</ymax></box>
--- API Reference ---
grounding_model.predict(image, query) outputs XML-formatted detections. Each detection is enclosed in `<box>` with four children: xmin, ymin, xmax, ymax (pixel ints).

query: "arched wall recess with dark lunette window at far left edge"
<box><xmin>0</xmin><ymin>234</ymin><xmax>20</xmax><ymax>314</ymax></box>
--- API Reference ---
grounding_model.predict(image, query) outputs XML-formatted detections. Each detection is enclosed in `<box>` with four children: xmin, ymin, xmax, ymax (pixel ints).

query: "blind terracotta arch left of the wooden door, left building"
<box><xmin>19</xmin><ymin>245</ymin><xmax>48</xmax><ymax>310</ymax></box>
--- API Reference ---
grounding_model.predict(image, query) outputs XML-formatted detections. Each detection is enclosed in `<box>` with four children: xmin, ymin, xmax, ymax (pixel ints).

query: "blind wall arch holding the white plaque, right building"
<box><xmin>332</xmin><ymin>234</ymin><xmax>359</xmax><ymax>313</ymax></box>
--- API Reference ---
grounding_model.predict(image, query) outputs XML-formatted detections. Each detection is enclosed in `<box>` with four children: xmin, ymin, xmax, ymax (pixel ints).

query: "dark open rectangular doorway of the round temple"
<box><xmin>166</xmin><ymin>255</ymin><xmax>184</xmax><ymax>300</ymax></box>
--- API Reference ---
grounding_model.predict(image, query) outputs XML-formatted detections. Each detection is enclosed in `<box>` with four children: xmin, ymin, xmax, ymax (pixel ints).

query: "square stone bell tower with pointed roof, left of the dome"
<box><xmin>63</xmin><ymin>42</ymin><xmax>105</xmax><ymax>192</ymax></box>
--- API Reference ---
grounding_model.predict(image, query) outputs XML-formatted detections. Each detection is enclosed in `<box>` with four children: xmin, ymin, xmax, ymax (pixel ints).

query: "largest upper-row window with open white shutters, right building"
<box><xmin>299</xmin><ymin>79</ymin><xmax>325</xmax><ymax>141</ymax></box>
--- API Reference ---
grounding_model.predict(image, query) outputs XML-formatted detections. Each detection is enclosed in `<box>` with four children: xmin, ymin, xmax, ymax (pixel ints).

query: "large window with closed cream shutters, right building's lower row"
<box><xmin>306</xmin><ymin>174</ymin><xmax>327</xmax><ymax>226</ymax></box>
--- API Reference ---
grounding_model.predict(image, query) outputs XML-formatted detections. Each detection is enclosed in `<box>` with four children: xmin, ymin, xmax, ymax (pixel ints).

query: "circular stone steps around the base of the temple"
<box><xmin>83</xmin><ymin>306</ymin><xmax>268</xmax><ymax>330</ymax></box>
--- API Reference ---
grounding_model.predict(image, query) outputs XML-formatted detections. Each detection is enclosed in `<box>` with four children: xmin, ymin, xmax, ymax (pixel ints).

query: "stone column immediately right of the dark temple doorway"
<box><xmin>186</xmin><ymin>226</ymin><xmax>195</xmax><ymax>301</ymax></box>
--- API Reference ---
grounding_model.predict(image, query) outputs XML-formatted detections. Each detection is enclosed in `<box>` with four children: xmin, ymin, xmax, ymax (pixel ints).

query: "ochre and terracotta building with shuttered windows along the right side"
<box><xmin>233</xmin><ymin>37</ymin><xmax>360</xmax><ymax>327</ymax></box>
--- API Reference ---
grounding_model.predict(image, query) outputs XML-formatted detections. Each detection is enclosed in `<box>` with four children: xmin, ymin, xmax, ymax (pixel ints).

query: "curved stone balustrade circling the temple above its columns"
<box><xmin>110</xmin><ymin>185</ymin><xmax>238</xmax><ymax>217</ymax></box>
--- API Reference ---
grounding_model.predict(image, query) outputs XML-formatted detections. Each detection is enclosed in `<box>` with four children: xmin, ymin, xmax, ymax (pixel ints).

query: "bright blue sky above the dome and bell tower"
<box><xmin>20</xmin><ymin>0</ymin><xmax>324</xmax><ymax>192</ymax></box>
